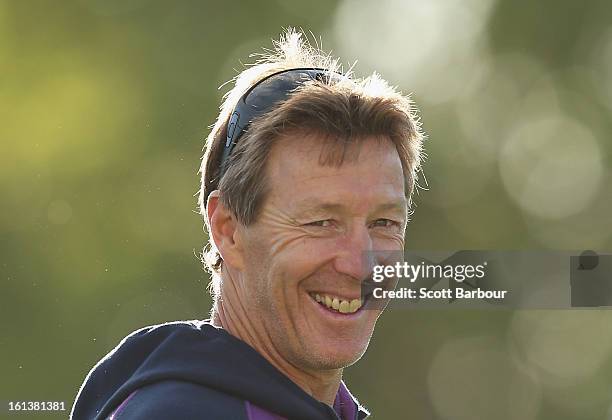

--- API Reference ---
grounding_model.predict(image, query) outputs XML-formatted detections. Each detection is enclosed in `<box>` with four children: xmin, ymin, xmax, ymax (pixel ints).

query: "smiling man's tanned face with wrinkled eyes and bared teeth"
<box><xmin>238</xmin><ymin>135</ymin><xmax>407</xmax><ymax>370</ymax></box>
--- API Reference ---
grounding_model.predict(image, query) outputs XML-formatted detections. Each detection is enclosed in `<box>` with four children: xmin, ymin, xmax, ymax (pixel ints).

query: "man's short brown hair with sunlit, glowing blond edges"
<box><xmin>198</xmin><ymin>29</ymin><xmax>423</xmax><ymax>282</ymax></box>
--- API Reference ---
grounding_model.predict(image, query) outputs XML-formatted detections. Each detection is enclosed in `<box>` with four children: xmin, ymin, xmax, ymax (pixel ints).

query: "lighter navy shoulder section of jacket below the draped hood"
<box><xmin>109</xmin><ymin>381</ymin><xmax>247</xmax><ymax>420</ymax></box>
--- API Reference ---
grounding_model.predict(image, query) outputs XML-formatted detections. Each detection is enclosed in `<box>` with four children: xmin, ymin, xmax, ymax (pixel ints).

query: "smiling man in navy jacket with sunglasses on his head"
<box><xmin>72</xmin><ymin>31</ymin><xmax>422</xmax><ymax>420</ymax></box>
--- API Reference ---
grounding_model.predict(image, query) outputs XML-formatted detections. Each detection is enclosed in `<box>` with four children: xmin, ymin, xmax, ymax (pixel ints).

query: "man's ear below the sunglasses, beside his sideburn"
<box><xmin>206</xmin><ymin>190</ymin><xmax>244</xmax><ymax>270</ymax></box>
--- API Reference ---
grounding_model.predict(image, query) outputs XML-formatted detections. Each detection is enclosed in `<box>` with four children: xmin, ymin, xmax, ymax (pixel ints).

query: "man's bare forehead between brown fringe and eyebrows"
<box><xmin>266</xmin><ymin>133</ymin><xmax>405</xmax><ymax>205</ymax></box>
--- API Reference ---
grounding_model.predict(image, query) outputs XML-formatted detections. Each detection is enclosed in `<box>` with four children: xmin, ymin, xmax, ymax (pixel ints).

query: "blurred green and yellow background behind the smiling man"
<box><xmin>0</xmin><ymin>0</ymin><xmax>612</xmax><ymax>420</ymax></box>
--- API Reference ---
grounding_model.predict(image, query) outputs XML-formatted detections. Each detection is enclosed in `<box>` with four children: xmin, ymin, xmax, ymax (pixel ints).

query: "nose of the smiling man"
<box><xmin>334</xmin><ymin>225</ymin><xmax>374</xmax><ymax>281</ymax></box>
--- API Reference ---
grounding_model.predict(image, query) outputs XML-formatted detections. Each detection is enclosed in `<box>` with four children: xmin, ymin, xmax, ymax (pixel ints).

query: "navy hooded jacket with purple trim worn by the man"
<box><xmin>71</xmin><ymin>321</ymin><xmax>368</xmax><ymax>420</ymax></box>
